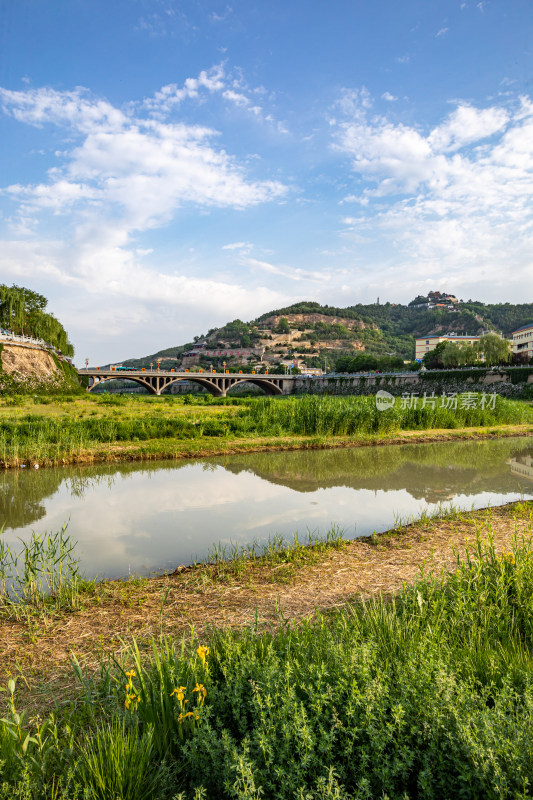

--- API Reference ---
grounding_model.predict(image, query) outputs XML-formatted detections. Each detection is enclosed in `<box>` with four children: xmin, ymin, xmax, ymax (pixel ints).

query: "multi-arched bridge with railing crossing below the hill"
<box><xmin>78</xmin><ymin>368</ymin><xmax>296</xmax><ymax>397</ymax></box>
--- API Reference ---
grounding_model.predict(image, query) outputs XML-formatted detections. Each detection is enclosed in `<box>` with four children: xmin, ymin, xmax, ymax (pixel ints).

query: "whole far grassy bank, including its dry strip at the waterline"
<box><xmin>0</xmin><ymin>395</ymin><xmax>533</xmax><ymax>467</ymax></box>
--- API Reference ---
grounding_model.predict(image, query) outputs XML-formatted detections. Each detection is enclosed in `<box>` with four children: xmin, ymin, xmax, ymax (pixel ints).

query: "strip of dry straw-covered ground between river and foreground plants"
<box><xmin>0</xmin><ymin>502</ymin><xmax>533</xmax><ymax>702</ymax></box>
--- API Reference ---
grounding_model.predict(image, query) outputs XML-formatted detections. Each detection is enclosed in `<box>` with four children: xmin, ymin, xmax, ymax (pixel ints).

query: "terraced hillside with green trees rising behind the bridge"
<box><xmin>124</xmin><ymin>297</ymin><xmax>533</xmax><ymax>369</ymax></box>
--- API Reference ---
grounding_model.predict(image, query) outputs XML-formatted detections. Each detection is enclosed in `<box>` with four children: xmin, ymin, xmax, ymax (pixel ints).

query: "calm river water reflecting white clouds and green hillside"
<box><xmin>0</xmin><ymin>439</ymin><xmax>533</xmax><ymax>576</ymax></box>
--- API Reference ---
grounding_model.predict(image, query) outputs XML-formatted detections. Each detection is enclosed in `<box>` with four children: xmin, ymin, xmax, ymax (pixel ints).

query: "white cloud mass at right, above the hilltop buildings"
<box><xmin>334</xmin><ymin>91</ymin><xmax>533</xmax><ymax>299</ymax></box>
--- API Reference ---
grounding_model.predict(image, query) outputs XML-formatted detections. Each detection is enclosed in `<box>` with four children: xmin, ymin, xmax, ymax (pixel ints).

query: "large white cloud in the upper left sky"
<box><xmin>0</xmin><ymin>85</ymin><xmax>285</xmax><ymax>231</ymax></box>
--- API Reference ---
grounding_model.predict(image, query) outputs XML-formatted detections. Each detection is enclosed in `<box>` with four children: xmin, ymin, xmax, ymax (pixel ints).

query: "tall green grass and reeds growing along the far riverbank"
<box><xmin>0</xmin><ymin>395</ymin><xmax>533</xmax><ymax>464</ymax></box>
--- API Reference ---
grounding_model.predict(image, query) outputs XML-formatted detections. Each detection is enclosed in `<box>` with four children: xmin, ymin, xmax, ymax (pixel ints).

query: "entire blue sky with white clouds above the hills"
<box><xmin>0</xmin><ymin>0</ymin><xmax>533</xmax><ymax>364</ymax></box>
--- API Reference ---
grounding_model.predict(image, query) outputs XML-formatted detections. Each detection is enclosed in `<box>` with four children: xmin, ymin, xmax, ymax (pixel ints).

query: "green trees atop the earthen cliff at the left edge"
<box><xmin>0</xmin><ymin>284</ymin><xmax>74</xmax><ymax>356</ymax></box>
